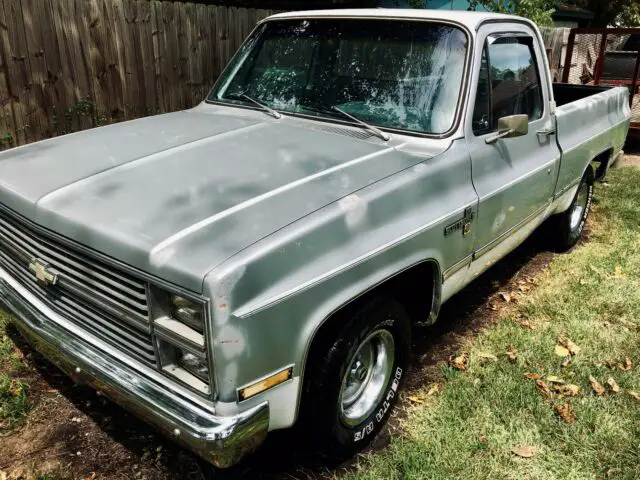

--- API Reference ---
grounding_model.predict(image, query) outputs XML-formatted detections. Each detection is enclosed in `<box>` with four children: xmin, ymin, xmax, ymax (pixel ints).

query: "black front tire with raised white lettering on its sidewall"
<box><xmin>302</xmin><ymin>297</ymin><xmax>411</xmax><ymax>460</ymax></box>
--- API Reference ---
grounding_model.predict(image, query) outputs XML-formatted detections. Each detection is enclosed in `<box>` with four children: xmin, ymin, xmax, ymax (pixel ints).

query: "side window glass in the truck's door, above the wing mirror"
<box><xmin>473</xmin><ymin>37</ymin><xmax>543</xmax><ymax>135</ymax></box>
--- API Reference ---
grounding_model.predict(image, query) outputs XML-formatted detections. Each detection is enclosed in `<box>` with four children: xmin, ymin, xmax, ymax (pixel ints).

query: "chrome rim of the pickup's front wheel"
<box><xmin>340</xmin><ymin>330</ymin><xmax>395</xmax><ymax>425</ymax></box>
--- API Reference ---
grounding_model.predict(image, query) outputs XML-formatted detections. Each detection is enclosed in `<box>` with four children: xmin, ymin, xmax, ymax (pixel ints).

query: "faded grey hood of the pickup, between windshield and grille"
<box><xmin>0</xmin><ymin>106</ymin><xmax>448</xmax><ymax>292</ymax></box>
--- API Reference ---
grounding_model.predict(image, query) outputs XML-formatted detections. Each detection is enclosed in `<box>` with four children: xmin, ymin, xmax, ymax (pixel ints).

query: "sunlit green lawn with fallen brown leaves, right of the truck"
<box><xmin>345</xmin><ymin>168</ymin><xmax>640</xmax><ymax>480</ymax></box>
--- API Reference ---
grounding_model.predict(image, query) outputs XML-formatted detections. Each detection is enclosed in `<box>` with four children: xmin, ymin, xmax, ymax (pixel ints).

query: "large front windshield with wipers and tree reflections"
<box><xmin>208</xmin><ymin>19</ymin><xmax>467</xmax><ymax>134</ymax></box>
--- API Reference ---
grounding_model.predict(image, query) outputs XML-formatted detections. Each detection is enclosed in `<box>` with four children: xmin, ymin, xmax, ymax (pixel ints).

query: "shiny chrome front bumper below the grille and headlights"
<box><xmin>0</xmin><ymin>268</ymin><xmax>269</xmax><ymax>468</ymax></box>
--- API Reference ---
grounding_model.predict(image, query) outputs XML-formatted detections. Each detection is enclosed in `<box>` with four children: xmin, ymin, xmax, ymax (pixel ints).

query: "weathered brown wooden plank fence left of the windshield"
<box><xmin>0</xmin><ymin>0</ymin><xmax>273</xmax><ymax>148</ymax></box>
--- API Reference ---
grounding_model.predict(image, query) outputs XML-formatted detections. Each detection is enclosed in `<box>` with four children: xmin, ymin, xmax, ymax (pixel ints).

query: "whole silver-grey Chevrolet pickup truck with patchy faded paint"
<box><xmin>0</xmin><ymin>9</ymin><xmax>630</xmax><ymax>467</ymax></box>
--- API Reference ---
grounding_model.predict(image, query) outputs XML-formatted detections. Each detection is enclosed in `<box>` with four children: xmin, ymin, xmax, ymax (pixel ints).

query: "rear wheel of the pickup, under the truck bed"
<box><xmin>551</xmin><ymin>167</ymin><xmax>594</xmax><ymax>251</ymax></box>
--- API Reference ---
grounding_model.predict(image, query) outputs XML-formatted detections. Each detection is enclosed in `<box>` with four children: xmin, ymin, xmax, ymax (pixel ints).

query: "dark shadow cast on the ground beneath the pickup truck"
<box><xmin>8</xmin><ymin>226</ymin><xmax>552</xmax><ymax>479</ymax></box>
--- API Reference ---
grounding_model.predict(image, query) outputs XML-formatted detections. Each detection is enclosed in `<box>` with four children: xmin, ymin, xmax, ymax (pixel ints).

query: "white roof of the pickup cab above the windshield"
<box><xmin>267</xmin><ymin>8</ymin><xmax>528</xmax><ymax>31</ymax></box>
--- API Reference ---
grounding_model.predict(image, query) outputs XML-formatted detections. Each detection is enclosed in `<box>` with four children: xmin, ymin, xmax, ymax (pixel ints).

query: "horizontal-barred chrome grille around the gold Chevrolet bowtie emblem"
<box><xmin>0</xmin><ymin>212</ymin><xmax>156</xmax><ymax>365</ymax></box>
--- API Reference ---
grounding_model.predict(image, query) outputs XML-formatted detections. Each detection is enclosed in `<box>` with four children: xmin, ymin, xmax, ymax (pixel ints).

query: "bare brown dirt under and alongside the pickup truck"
<box><xmin>0</xmin><ymin>223</ymin><xmax>568</xmax><ymax>480</ymax></box>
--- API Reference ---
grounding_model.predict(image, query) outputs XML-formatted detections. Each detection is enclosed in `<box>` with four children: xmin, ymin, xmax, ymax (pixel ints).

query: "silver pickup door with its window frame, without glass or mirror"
<box><xmin>466</xmin><ymin>24</ymin><xmax>560</xmax><ymax>259</ymax></box>
